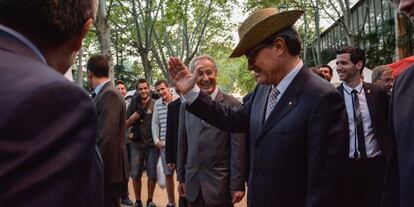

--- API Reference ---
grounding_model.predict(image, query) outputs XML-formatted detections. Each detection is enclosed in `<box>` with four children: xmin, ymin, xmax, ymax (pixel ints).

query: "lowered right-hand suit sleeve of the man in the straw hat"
<box><xmin>306</xmin><ymin>92</ymin><xmax>349</xmax><ymax>207</ymax></box>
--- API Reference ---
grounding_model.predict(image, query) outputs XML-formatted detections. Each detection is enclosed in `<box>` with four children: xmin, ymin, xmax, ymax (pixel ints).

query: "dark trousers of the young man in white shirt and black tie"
<box><xmin>345</xmin><ymin>156</ymin><xmax>386</xmax><ymax>207</ymax></box>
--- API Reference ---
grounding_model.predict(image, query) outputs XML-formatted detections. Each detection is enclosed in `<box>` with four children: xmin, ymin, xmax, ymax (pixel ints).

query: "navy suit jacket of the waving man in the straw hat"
<box><xmin>188</xmin><ymin>67</ymin><xmax>349</xmax><ymax>207</ymax></box>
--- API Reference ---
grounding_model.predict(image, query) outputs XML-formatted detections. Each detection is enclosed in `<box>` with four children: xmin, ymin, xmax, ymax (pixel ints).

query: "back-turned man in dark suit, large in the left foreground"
<box><xmin>0</xmin><ymin>0</ymin><xmax>103</xmax><ymax>207</ymax></box>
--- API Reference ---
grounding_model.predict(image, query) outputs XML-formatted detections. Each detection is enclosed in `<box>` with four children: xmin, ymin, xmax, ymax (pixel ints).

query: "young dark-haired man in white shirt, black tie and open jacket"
<box><xmin>336</xmin><ymin>47</ymin><xmax>390</xmax><ymax>207</ymax></box>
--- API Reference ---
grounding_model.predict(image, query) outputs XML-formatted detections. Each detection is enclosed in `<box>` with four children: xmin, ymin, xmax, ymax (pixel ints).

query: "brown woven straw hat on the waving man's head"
<box><xmin>230</xmin><ymin>8</ymin><xmax>304</xmax><ymax>57</ymax></box>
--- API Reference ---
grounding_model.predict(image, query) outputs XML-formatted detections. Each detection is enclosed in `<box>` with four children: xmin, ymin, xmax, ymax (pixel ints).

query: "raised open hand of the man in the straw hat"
<box><xmin>168</xmin><ymin>57</ymin><xmax>197</xmax><ymax>94</ymax></box>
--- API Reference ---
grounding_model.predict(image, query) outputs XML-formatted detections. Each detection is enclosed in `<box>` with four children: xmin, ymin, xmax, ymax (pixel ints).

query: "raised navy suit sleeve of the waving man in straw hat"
<box><xmin>186</xmin><ymin>91</ymin><xmax>251</xmax><ymax>133</ymax></box>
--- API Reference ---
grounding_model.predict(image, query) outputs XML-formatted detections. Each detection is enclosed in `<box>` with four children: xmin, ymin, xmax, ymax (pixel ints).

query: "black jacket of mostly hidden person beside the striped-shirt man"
<box><xmin>165</xmin><ymin>98</ymin><xmax>181</xmax><ymax>164</ymax></box>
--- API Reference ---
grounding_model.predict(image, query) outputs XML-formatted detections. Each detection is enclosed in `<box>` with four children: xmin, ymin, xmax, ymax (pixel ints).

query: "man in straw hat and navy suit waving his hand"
<box><xmin>169</xmin><ymin>8</ymin><xmax>348</xmax><ymax>207</ymax></box>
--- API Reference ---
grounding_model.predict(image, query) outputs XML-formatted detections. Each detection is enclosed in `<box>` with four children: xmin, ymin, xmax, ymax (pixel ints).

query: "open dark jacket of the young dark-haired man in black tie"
<box><xmin>337</xmin><ymin>82</ymin><xmax>391</xmax><ymax>159</ymax></box>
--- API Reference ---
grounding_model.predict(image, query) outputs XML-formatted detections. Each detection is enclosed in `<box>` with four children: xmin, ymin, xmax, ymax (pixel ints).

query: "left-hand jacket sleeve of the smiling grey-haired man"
<box><xmin>177</xmin><ymin>103</ymin><xmax>187</xmax><ymax>182</ymax></box>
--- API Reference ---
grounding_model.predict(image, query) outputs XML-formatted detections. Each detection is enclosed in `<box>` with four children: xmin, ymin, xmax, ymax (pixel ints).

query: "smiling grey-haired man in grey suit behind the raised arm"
<box><xmin>177</xmin><ymin>55</ymin><xmax>246</xmax><ymax>207</ymax></box>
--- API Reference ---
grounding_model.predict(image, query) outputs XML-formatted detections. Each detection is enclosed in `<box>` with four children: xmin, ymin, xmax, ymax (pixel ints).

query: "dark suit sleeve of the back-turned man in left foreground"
<box><xmin>0</xmin><ymin>81</ymin><xmax>103</xmax><ymax>206</ymax></box>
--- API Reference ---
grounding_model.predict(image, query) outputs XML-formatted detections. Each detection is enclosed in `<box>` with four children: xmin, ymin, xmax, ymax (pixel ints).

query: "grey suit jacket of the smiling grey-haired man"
<box><xmin>177</xmin><ymin>91</ymin><xmax>246</xmax><ymax>205</ymax></box>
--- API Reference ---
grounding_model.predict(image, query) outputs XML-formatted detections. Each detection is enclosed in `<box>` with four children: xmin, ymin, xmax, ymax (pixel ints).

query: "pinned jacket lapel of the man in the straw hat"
<box><xmin>259</xmin><ymin>67</ymin><xmax>307</xmax><ymax>141</ymax></box>
